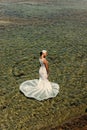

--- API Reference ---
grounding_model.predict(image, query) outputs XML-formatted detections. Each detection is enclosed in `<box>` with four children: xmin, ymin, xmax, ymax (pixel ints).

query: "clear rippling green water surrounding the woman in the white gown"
<box><xmin>0</xmin><ymin>1</ymin><xmax>87</xmax><ymax>130</ymax></box>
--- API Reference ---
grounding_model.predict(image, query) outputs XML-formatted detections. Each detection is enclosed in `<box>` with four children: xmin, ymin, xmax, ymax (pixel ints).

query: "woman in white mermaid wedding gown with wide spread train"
<box><xmin>19</xmin><ymin>50</ymin><xmax>59</xmax><ymax>101</ymax></box>
